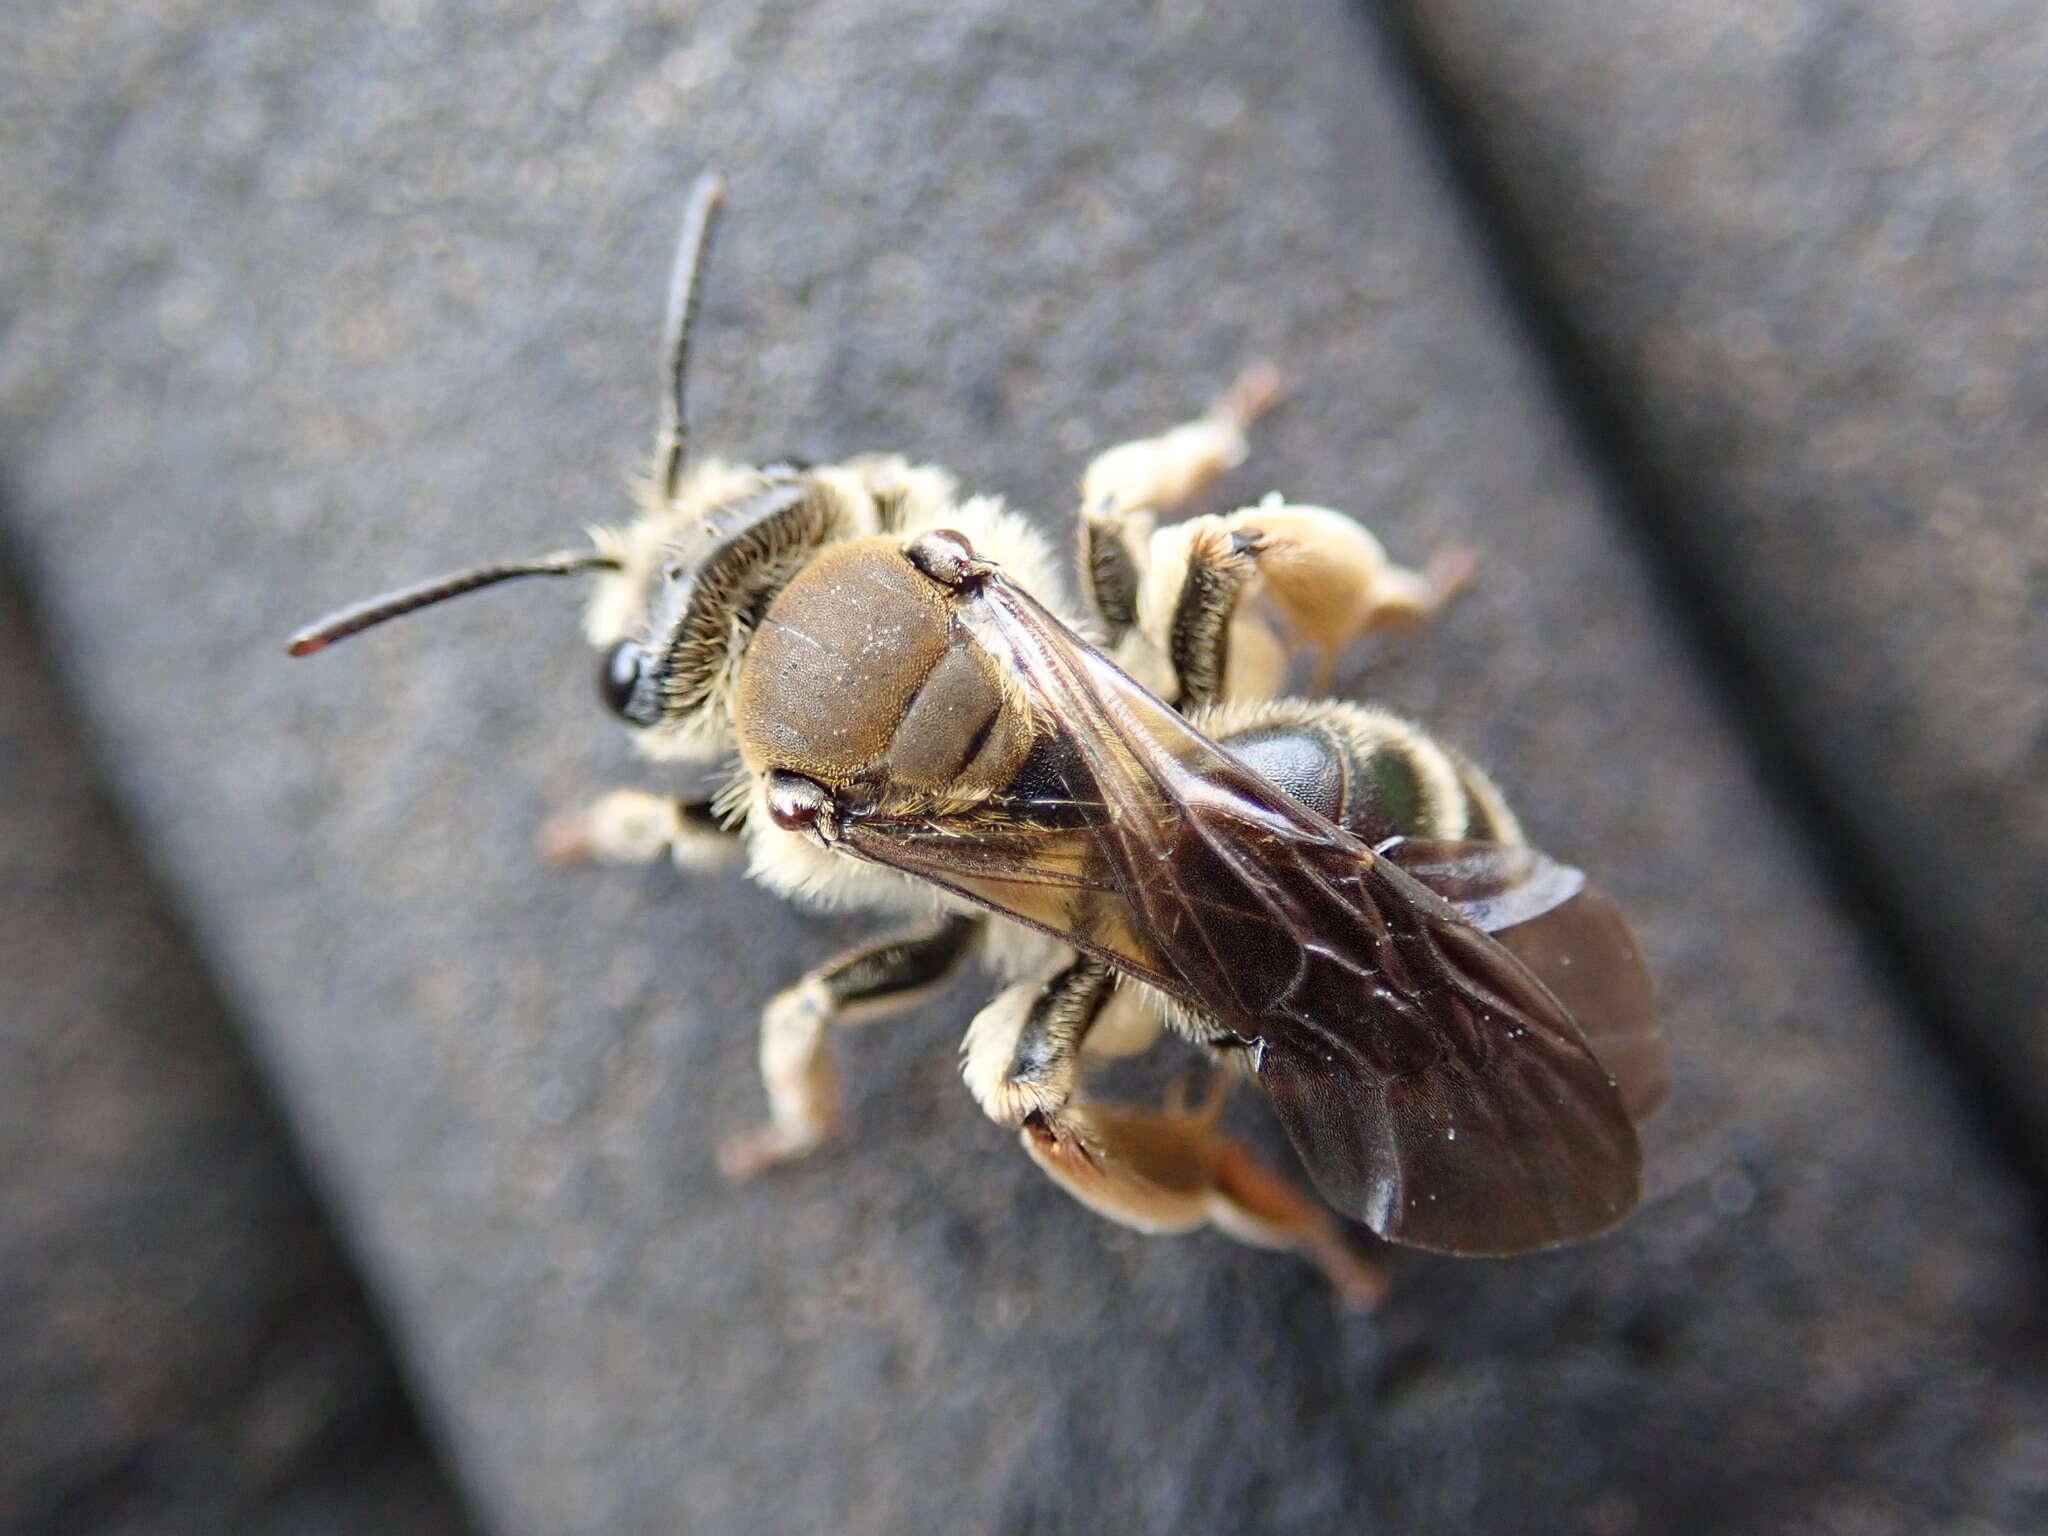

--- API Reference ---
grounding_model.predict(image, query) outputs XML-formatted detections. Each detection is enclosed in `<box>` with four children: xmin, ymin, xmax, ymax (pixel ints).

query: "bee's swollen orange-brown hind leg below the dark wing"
<box><xmin>1022</xmin><ymin>1073</ymin><xmax>1386</xmax><ymax>1311</ymax></box>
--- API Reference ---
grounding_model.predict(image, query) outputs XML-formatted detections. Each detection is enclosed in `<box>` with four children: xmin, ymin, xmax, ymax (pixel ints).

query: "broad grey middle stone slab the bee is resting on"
<box><xmin>0</xmin><ymin>0</ymin><xmax>2048</xmax><ymax>1532</ymax></box>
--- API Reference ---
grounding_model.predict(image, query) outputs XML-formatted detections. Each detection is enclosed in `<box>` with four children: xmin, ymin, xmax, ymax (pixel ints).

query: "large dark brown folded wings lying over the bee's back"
<box><xmin>840</xmin><ymin>571</ymin><xmax>1640</xmax><ymax>1253</ymax></box>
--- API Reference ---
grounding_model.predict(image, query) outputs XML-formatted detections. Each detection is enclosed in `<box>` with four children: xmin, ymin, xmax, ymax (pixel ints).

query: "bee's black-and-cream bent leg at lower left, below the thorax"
<box><xmin>719</xmin><ymin>915</ymin><xmax>981</xmax><ymax>1180</ymax></box>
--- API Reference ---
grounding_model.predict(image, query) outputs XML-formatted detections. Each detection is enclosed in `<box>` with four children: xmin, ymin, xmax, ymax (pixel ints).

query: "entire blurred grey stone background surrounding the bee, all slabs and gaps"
<box><xmin>0</xmin><ymin>0</ymin><xmax>2048</xmax><ymax>1536</ymax></box>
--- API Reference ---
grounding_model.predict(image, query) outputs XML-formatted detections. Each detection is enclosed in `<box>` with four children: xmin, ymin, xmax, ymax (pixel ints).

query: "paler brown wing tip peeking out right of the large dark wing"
<box><xmin>1376</xmin><ymin>838</ymin><xmax>1669</xmax><ymax>1122</ymax></box>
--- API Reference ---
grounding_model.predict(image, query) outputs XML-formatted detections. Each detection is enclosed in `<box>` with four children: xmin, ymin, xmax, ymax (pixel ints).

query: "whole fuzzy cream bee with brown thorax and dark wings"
<box><xmin>289</xmin><ymin>176</ymin><xmax>1665</xmax><ymax>1305</ymax></box>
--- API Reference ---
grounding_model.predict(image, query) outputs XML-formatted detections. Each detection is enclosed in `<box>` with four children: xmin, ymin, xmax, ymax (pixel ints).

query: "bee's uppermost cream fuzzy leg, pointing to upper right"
<box><xmin>1079</xmin><ymin>362</ymin><xmax>1280</xmax><ymax>645</ymax></box>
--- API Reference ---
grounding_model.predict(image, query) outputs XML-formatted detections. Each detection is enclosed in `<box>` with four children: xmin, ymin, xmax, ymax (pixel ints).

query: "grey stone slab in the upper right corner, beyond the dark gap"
<box><xmin>1389</xmin><ymin>0</ymin><xmax>2048</xmax><ymax>1146</ymax></box>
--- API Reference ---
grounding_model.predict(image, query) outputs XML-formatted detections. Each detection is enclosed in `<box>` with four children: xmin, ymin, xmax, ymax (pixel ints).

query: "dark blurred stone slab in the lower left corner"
<box><xmin>0</xmin><ymin>552</ymin><xmax>463</xmax><ymax>1536</ymax></box>
